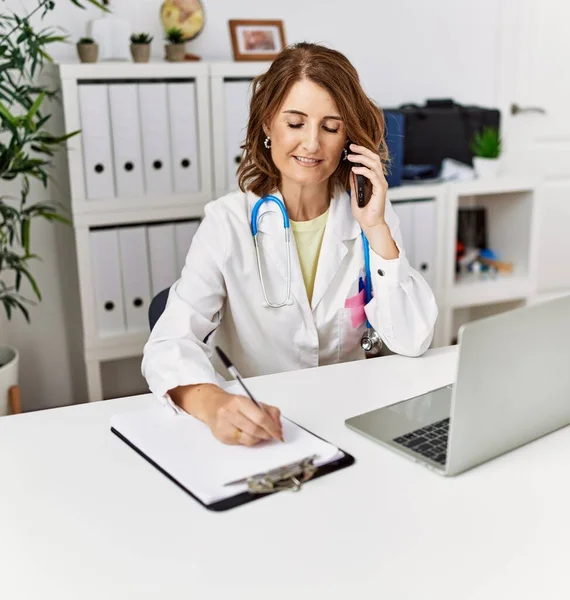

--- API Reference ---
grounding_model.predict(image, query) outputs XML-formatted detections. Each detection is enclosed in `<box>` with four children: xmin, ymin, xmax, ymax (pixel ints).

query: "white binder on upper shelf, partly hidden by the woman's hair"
<box><xmin>224</xmin><ymin>81</ymin><xmax>251</xmax><ymax>190</ymax></box>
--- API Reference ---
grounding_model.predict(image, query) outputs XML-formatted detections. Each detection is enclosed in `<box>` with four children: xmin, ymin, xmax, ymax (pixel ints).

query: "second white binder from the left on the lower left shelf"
<box><xmin>119</xmin><ymin>226</ymin><xmax>151</xmax><ymax>331</ymax></box>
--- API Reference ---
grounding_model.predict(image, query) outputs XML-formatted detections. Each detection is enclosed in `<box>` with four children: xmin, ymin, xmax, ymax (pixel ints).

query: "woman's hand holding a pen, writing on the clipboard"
<box><xmin>170</xmin><ymin>384</ymin><xmax>283</xmax><ymax>446</ymax></box>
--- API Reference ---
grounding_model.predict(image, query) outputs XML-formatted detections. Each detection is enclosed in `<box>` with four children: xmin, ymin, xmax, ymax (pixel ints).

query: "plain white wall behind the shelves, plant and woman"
<box><xmin>0</xmin><ymin>0</ymin><xmax>500</xmax><ymax>410</ymax></box>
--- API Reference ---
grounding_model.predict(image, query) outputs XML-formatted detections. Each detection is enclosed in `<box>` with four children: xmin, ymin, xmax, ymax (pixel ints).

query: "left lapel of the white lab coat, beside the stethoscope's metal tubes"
<box><xmin>248</xmin><ymin>192</ymin><xmax>310</xmax><ymax>310</ymax></box>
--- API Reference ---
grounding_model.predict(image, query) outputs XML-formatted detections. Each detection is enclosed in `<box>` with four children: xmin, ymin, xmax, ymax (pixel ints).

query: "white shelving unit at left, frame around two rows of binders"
<box><xmin>45</xmin><ymin>62</ymin><xmax>213</xmax><ymax>401</ymax></box>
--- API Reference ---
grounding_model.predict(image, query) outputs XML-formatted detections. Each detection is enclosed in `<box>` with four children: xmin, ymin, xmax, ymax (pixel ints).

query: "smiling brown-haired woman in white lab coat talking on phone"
<box><xmin>142</xmin><ymin>43</ymin><xmax>437</xmax><ymax>446</ymax></box>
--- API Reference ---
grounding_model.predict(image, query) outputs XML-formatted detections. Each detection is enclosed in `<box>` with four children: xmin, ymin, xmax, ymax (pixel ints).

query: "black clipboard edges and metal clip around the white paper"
<box><xmin>111</xmin><ymin>410</ymin><xmax>355</xmax><ymax>512</ymax></box>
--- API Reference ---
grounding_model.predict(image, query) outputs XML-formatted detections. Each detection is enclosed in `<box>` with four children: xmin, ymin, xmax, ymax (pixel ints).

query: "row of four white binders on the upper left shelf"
<box><xmin>78</xmin><ymin>80</ymin><xmax>200</xmax><ymax>200</ymax></box>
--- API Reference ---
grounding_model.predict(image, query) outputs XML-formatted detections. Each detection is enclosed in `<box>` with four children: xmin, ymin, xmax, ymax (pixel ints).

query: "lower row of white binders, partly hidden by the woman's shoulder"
<box><xmin>89</xmin><ymin>220</ymin><xmax>199</xmax><ymax>336</ymax></box>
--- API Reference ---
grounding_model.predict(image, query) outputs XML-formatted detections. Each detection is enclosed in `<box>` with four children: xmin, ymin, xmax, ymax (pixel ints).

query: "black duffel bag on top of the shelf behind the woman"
<box><xmin>399</xmin><ymin>99</ymin><xmax>501</xmax><ymax>171</ymax></box>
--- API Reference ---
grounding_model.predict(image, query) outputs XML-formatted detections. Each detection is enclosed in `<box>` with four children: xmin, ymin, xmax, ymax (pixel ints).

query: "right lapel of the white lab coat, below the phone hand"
<box><xmin>311</xmin><ymin>190</ymin><xmax>360</xmax><ymax>310</ymax></box>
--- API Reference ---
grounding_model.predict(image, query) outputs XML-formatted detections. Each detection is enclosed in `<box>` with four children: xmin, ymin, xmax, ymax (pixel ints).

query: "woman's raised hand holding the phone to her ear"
<box><xmin>347</xmin><ymin>144</ymin><xmax>399</xmax><ymax>258</ymax></box>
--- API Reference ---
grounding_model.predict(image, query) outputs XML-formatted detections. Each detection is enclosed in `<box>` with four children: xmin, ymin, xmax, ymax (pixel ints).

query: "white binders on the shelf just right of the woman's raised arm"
<box><xmin>392</xmin><ymin>200</ymin><xmax>437</xmax><ymax>286</ymax></box>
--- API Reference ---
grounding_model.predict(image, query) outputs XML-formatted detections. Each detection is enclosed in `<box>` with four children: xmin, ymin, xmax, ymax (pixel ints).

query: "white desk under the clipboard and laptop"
<box><xmin>0</xmin><ymin>348</ymin><xmax>570</xmax><ymax>600</ymax></box>
